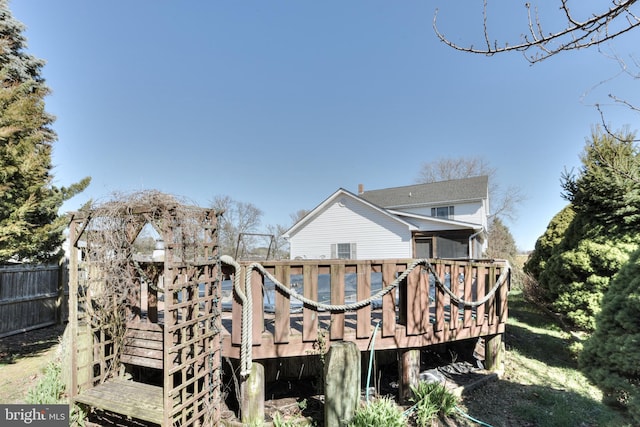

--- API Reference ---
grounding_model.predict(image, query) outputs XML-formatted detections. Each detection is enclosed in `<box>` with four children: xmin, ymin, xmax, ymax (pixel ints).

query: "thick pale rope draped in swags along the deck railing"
<box><xmin>220</xmin><ymin>255</ymin><xmax>511</xmax><ymax>377</ymax></box>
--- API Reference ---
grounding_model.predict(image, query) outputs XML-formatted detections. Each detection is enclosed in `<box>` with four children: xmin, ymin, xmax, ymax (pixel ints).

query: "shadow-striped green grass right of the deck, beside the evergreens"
<box><xmin>460</xmin><ymin>292</ymin><xmax>633</xmax><ymax>427</ymax></box>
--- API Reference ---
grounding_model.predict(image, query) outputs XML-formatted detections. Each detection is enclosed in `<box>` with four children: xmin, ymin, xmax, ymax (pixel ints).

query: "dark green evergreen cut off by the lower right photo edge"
<box><xmin>580</xmin><ymin>247</ymin><xmax>640</xmax><ymax>424</ymax></box>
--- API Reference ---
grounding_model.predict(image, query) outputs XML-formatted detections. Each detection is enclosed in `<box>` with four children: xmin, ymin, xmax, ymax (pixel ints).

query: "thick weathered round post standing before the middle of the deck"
<box><xmin>324</xmin><ymin>341</ymin><xmax>361</xmax><ymax>427</ymax></box>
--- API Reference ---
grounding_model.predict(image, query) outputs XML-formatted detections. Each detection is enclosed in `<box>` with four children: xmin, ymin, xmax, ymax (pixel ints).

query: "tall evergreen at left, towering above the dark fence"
<box><xmin>0</xmin><ymin>0</ymin><xmax>89</xmax><ymax>261</ymax></box>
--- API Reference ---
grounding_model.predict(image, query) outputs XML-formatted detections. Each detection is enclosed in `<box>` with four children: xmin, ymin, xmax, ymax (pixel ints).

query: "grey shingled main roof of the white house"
<box><xmin>358</xmin><ymin>175</ymin><xmax>489</xmax><ymax>209</ymax></box>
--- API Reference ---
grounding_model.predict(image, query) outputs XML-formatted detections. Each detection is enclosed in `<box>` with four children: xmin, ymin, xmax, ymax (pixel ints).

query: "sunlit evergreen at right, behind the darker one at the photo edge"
<box><xmin>527</xmin><ymin>128</ymin><xmax>640</xmax><ymax>330</ymax></box>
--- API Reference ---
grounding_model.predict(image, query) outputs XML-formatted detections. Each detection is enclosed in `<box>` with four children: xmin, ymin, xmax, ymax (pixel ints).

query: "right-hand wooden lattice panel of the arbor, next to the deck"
<box><xmin>165</xmin><ymin>209</ymin><xmax>222</xmax><ymax>426</ymax></box>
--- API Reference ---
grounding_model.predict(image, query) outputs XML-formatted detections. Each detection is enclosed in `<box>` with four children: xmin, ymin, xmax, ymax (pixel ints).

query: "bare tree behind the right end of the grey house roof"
<box><xmin>416</xmin><ymin>157</ymin><xmax>525</xmax><ymax>224</ymax></box>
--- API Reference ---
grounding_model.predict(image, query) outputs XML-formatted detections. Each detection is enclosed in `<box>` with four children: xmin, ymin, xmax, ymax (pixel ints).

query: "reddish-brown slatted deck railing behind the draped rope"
<box><xmin>222</xmin><ymin>260</ymin><xmax>509</xmax><ymax>360</ymax></box>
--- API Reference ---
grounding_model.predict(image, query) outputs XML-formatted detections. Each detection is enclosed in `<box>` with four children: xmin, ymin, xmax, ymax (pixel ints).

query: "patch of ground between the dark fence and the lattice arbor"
<box><xmin>0</xmin><ymin>325</ymin><xmax>64</xmax><ymax>403</ymax></box>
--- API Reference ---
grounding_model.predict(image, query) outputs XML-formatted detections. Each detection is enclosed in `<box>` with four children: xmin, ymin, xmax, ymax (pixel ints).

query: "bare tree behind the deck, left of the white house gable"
<box><xmin>211</xmin><ymin>195</ymin><xmax>262</xmax><ymax>256</ymax></box>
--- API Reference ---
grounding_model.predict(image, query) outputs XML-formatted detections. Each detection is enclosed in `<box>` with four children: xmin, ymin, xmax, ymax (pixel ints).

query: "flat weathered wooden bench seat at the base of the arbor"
<box><xmin>74</xmin><ymin>378</ymin><xmax>164</xmax><ymax>425</ymax></box>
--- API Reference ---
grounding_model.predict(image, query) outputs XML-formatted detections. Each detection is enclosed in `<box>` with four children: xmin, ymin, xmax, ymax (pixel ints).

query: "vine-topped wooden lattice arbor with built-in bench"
<box><xmin>69</xmin><ymin>197</ymin><xmax>222</xmax><ymax>426</ymax></box>
